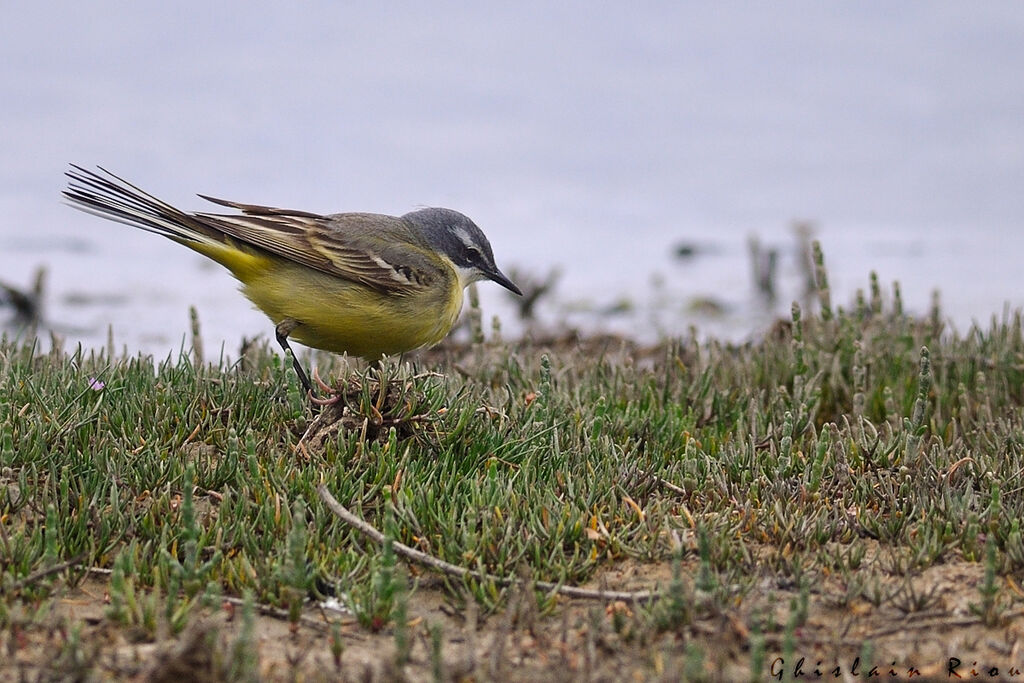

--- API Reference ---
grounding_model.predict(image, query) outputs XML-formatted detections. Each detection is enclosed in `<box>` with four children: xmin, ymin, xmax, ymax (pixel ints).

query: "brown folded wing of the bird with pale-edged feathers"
<box><xmin>195</xmin><ymin>197</ymin><xmax>442</xmax><ymax>295</ymax></box>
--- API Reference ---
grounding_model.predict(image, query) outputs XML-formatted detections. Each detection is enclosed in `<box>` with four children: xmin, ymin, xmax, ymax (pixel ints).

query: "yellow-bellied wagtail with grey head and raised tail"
<box><xmin>63</xmin><ymin>165</ymin><xmax>522</xmax><ymax>391</ymax></box>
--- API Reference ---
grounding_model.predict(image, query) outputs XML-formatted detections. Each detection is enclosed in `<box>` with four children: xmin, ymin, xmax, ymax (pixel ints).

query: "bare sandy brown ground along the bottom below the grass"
<box><xmin>0</xmin><ymin>548</ymin><xmax>1024</xmax><ymax>682</ymax></box>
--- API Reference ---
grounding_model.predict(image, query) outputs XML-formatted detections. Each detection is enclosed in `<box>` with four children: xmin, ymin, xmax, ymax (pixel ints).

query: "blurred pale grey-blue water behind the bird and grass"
<box><xmin>0</xmin><ymin>0</ymin><xmax>1024</xmax><ymax>355</ymax></box>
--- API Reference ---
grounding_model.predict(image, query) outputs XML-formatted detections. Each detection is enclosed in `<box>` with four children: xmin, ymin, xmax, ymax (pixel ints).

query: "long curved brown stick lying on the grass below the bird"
<box><xmin>316</xmin><ymin>484</ymin><xmax>660</xmax><ymax>602</ymax></box>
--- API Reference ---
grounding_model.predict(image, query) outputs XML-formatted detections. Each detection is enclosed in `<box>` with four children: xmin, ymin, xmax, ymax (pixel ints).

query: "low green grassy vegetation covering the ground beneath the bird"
<box><xmin>0</xmin><ymin>262</ymin><xmax>1024</xmax><ymax>680</ymax></box>
